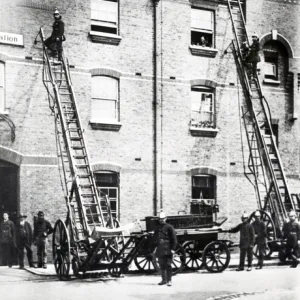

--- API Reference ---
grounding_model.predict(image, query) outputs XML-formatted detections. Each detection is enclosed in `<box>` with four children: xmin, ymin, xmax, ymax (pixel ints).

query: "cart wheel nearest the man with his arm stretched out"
<box><xmin>203</xmin><ymin>241</ymin><xmax>230</xmax><ymax>273</ymax></box>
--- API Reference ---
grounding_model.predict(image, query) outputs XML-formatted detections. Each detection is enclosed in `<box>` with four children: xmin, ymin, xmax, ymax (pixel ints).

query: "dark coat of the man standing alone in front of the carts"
<box><xmin>154</xmin><ymin>223</ymin><xmax>177</xmax><ymax>257</ymax></box>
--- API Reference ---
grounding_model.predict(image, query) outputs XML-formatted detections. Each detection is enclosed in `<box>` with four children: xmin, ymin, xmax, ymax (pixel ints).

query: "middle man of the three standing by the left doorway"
<box><xmin>16</xmin><ymin>214</ymin><xmax>33</xmax><ymax>269</ymax></box>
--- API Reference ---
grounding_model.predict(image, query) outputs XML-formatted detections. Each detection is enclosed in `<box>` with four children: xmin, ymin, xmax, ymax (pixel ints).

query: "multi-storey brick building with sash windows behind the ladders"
<box><xmin>0</xmin><ymin>0</ymin><xmax>300</xmax><ymax>262</ymax></box>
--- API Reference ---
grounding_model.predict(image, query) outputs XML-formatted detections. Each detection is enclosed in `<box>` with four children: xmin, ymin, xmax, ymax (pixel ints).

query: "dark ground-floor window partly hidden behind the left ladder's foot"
<box><xmin>94</xmin><ymin>171</ymin><xmax>119</xmax><ymax>221</ymax></box>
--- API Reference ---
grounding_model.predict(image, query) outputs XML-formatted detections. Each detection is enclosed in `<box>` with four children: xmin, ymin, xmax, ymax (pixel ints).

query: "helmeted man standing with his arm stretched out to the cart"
<box><xmin>229</xmin><ymin>213</ymin><xmax>255</xmax><ymax>271</ymax></box>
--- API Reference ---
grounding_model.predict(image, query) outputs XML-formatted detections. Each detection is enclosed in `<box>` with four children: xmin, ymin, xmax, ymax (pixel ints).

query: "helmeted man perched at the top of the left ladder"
<box><xmin>44</xmin><ymin>9</ymin><xmax>65</xmax><ymax>61</ymax></box>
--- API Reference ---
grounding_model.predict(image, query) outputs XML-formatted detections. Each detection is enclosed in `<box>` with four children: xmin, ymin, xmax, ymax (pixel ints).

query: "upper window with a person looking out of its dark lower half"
<box><xmin>191</xmin><ymin>8</ymin><xmax>214</xmax><ymax>48</ymax></box>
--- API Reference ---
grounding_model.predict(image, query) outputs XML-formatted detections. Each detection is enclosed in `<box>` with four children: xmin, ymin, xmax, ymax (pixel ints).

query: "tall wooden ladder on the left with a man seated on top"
<box><xmin>39</xmin><ymin>28</ymin><xmax>114</xmax><ymax>241</ymax></box>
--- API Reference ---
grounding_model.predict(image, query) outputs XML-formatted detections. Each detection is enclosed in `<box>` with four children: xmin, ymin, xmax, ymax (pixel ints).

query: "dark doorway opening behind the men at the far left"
<box><xmin>0</xmin><ymin>160</ymin><xmax>19</xmax><ymax>265</ymax></box>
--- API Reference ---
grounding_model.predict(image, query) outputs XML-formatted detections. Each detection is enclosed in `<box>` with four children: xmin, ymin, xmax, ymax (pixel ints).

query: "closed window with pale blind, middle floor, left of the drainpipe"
<box><xmin>91</xmin><ymin>76</ymin><xmax>119</xmax><ymax>122</ymax></box>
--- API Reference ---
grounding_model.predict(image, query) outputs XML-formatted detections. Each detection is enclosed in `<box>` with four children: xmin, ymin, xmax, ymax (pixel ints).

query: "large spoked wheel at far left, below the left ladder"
<box><xmin>52</xmin><ymin>220</ymin><xmax>70</xmax><ymax>280</ymax></box>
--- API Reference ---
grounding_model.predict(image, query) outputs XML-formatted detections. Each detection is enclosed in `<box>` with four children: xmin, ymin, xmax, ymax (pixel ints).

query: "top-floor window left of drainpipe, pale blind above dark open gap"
<box><xmin>91</xmin><ymin>0</ymin><xmax>119</xmax><ymax>35</ymax></box>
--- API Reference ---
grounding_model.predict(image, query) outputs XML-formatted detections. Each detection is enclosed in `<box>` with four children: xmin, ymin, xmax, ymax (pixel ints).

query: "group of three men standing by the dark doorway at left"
<box><xmin>0</xmin><ymin>211</ymin><xmax>53</xmax><ymax>269</ymax></box>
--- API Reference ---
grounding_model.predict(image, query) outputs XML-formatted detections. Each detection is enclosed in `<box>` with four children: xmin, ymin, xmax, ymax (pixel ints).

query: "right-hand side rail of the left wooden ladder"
<box><xmin>62</xmin><ymin>57</ymin><xmax>104</xmax><ymax>226</ymax></box>
